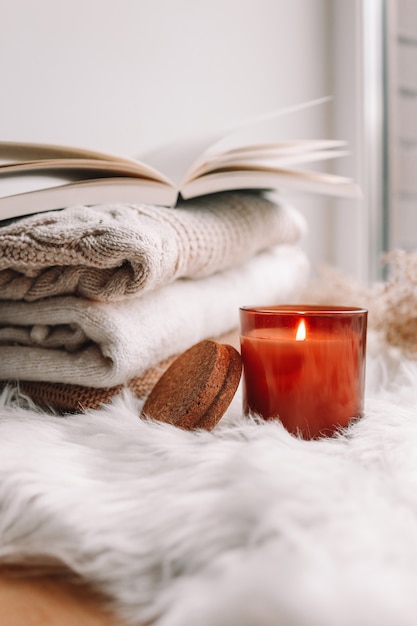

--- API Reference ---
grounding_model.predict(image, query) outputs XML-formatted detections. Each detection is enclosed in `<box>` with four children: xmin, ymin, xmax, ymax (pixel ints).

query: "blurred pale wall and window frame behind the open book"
<box><xmin>0</xmin><ymin>0</ymin><xmax>410</xmax><ymax>280</ymax></box>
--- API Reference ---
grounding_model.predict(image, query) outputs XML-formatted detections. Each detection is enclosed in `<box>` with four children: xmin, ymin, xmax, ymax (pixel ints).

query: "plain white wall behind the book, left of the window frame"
<box><xmin>0</xmin><ymin>0</ymin><xmax>356</xmax><ymax>272</ymax></box>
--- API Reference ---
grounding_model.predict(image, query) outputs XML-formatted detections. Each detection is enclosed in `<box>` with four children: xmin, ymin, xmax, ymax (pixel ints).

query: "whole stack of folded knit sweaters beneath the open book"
<box><xmin>0</xmin><ymin>192</ymin><xmax>309</xmax><ymax>411</ymax></box>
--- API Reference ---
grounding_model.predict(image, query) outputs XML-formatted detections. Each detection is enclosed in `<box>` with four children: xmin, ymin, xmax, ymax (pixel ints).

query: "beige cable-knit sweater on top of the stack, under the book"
<box><xmin>0</xmin><ymin>192</ymin><xmax>306</xmax><ymax>302</ymax></box>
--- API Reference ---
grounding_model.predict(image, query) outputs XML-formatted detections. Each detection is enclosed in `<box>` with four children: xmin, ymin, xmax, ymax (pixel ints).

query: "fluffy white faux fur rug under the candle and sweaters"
<box><xmin>0</xmin><ymin>336</ymin><xmax>417</xmax><ymax>626</ymax></box>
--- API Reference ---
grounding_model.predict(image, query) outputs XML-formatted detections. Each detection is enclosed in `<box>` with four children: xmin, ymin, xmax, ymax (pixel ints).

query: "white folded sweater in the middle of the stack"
<box><xmin>0</xmin><ymin>245</ymin><xmax>309</xmax><ymax>387</ymax></box>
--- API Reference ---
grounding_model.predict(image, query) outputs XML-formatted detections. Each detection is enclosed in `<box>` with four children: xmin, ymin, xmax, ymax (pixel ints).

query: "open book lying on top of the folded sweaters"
<box><xmin>0</xmin><ymin>101</ymin><xmax>359</xmax><ymax>220</ymax></box>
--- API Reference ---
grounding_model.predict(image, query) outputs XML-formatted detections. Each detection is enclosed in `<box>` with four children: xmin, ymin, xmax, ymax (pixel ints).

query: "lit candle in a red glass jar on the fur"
<box><xmin>240</xmin><ymin>305</ymin><xmax>368</xmax><ymax>439</ymax></box>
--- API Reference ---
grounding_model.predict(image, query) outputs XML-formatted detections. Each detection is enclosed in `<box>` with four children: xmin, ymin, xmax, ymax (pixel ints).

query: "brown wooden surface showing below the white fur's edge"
<box><xmin>0</xmin><ymin>571</ymin><xmax>125</xmax><ymax>626</ymax></box>
